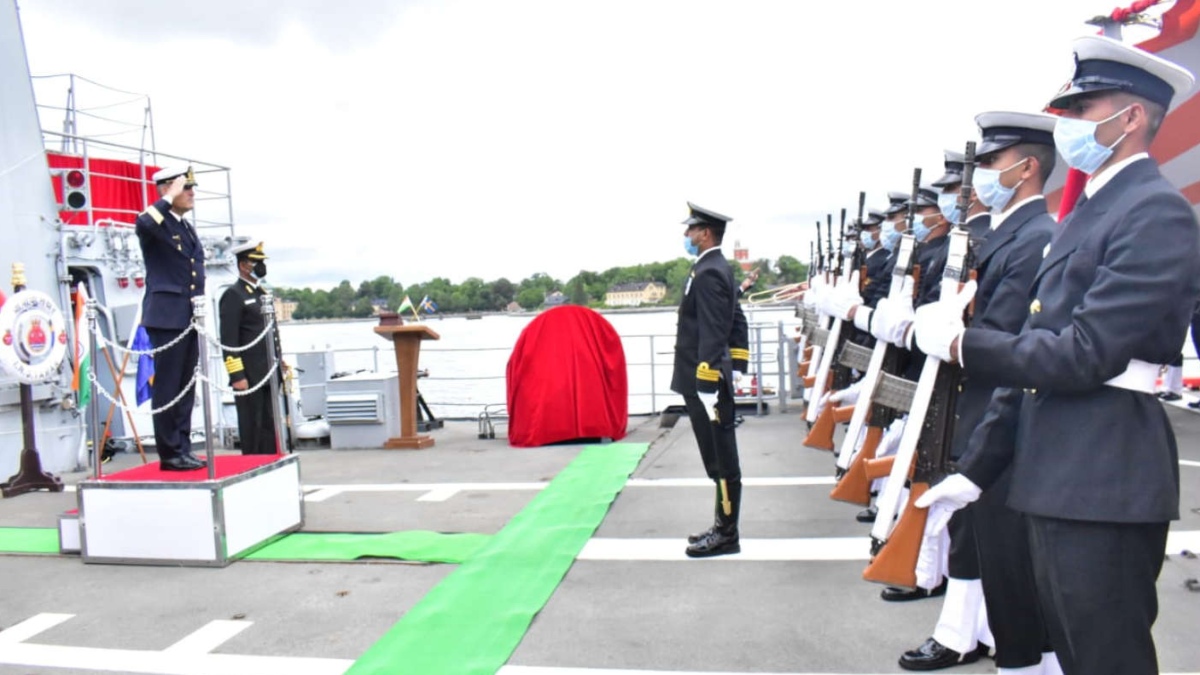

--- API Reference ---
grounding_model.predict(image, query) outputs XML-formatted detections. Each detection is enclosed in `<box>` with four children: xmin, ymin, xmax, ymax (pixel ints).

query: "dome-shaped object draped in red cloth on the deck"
<box><xmin>508</xmin><ymin>305</ymin><xmax>629</xmax><ymax>448</ymax></box>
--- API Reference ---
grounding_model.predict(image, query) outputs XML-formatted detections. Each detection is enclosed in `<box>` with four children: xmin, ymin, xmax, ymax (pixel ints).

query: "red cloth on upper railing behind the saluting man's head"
<box><xmin>46</xmin><ymin>153</ymin><xmax>158</xmax><ymax>225</ymax></box>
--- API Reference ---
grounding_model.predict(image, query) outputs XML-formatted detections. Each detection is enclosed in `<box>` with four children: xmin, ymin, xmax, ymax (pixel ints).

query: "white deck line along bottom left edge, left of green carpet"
<box><xmin>0</xmin><ymin>644</ymin><xmax>353</xmax><ymax>675</ymax></box>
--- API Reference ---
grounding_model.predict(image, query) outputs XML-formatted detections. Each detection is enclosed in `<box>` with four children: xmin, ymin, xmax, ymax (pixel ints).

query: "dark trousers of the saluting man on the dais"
<box><xmin>146</xmin><ymin>328</ymin><xmax>200</xmax><ymax>459</ymax></box>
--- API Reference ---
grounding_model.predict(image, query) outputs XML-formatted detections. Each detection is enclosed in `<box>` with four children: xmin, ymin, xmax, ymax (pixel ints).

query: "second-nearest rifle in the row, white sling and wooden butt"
<box><xmin>829</xmin><ymin>230</ymin><xmax>920</xmax><ymax>506</ymax></box>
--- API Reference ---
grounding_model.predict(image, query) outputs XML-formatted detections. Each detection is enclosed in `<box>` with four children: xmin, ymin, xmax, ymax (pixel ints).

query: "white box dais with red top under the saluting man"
<box><xmin>59</xmin><ymin>455</ymin><xmax>304</xmax><ymax>567</ymax></box>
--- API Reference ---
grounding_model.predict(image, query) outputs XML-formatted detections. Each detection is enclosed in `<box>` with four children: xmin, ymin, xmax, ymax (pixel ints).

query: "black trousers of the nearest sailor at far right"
<box><xmin>1027</xmin><ymin>515</ymin><xmax>1169</xmax><ymax>675</ymax></box>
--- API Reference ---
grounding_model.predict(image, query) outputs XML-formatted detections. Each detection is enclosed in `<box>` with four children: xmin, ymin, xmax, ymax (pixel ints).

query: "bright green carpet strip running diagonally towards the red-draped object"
<box><xmin>350</xmin><ymin>443</ymin><xmax>649</xmax><ymax>675</ymax></box>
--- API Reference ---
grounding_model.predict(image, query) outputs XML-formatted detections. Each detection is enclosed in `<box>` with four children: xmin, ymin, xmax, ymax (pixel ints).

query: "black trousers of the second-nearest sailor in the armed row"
<box><xmin>967</xmin><ymin>471</ymin><xmax>1050</xmax><ymax>668</ymax></box>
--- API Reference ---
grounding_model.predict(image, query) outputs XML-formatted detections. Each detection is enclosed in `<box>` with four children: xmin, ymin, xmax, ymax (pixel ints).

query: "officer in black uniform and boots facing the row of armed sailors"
<box><xmin>671</xmin><ymin>202</ymin><xmax>742</xmax><ymax>557</ymax></box>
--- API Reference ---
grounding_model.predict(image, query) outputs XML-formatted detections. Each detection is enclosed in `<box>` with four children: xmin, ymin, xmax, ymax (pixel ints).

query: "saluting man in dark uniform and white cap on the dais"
<box><xmin>136</xmin><ymin>166</ymin><xmax>206</xmax><ymax>471</ymax></box>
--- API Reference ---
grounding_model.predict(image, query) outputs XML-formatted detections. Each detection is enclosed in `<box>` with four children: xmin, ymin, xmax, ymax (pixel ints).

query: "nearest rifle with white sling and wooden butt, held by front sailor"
<box><xmin>863</xmin><ymin>142</ymin><xmax>974</xmax><ymax>589</ymax></box>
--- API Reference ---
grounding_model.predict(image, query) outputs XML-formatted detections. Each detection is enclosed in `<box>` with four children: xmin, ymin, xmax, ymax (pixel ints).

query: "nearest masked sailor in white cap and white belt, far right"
<box><xmin>913</xmin><ymin>37</ymin><xmax>1200</xmax><ymax>675</ymax></box>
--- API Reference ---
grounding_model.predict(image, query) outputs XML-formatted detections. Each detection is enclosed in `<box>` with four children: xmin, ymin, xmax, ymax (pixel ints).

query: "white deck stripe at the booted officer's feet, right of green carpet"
<box><xmin>576</xmin><ymin>530</ymin><xmax>1200</xmax><ymax>562</ymax></box>
